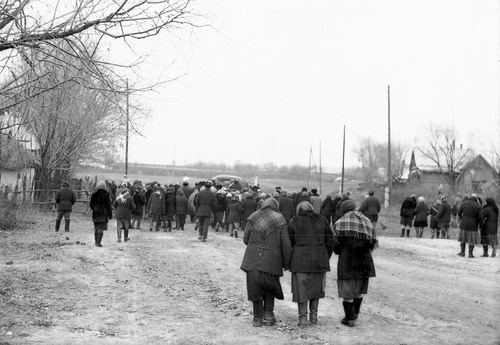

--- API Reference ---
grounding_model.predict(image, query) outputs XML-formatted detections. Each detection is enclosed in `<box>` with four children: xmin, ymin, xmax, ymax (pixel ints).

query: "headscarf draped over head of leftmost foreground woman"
<box><xmin>248</xmin><ymin>198</ymin><xmax>287</xmax><ymax>235</ymax></box>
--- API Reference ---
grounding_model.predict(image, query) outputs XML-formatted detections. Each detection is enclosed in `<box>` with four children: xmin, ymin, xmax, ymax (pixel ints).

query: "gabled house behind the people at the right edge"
<box><xmin>456</xmin><ymin>155</ymin><xmax>500</xmax><ymax>195</ymax></box>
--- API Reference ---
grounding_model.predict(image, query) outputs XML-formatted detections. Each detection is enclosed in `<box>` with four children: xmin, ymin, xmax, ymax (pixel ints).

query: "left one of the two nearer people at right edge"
<box><xmin>457</xmin><ymin>194</ymin><xmax>483</xmax><ymax>258</ymax></box>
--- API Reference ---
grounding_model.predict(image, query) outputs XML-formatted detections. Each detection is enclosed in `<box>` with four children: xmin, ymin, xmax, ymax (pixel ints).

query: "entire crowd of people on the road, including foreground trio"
<box><xmin>52</xmin><ymin>180</ymin><xmax>499</xmax><ymax>327</ymax></box>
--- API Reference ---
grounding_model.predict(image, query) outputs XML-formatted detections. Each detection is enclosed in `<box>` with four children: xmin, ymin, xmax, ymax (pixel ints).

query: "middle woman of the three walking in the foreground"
<box><xmin>288</xmin><ymin>201</ymin><xmax>333</xmax><ymax>326</ymax></box>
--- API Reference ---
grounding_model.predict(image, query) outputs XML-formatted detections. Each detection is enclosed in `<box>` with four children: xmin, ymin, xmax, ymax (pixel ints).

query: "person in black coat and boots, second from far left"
<box><xmin>90</xmin><ymin>181</ymin><xmax>113</xmax><ymax>247</ymax></box>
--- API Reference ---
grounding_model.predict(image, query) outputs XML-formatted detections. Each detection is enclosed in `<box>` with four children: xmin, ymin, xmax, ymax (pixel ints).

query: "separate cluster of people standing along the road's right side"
<box><xmin>400</xmin><ymin>194</ymin><xmax>499</xmax><ymax>258</ymax></box>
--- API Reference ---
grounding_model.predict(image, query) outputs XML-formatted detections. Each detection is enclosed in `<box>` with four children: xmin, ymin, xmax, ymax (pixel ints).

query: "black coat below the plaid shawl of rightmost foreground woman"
<box><xmin>333</xmin><ymin>237</ymin><xmax>375</xmax><ymax>279</ymax></box>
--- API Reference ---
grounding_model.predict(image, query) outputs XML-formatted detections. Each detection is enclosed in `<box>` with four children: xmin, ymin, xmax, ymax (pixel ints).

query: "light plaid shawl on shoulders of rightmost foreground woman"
<box><xmin>333</xmin><ymin>211</ymin><xmax>378</xmax><ymax>245</ymax></box>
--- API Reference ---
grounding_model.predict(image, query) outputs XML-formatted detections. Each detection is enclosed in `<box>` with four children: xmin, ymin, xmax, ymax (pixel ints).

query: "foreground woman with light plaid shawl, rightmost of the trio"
<box><xmin>333</xmin><ymin>200</ymin><xmax>378</xmax><ymax>327</ymax></box>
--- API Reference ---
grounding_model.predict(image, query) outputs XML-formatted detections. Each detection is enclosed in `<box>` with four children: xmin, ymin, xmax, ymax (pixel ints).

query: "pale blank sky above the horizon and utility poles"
<box><xmin>112</xmin><ymin>0</ymin><xmax>500</xmax><ymax>167</ymax></box>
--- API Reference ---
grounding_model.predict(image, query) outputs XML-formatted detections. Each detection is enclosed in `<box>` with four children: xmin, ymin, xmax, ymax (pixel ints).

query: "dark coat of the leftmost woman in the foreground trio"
<box><xmin>240</xmin><ymin>223</ymin><xmax>292</xmax><ymax>277</ymax></box>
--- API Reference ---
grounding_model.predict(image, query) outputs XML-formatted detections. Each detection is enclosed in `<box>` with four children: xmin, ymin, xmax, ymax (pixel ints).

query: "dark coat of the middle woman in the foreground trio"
<box><xmin>288</xmin><ymin>211</ymin><xmax>333</xmax><ymax>273</ymax></box>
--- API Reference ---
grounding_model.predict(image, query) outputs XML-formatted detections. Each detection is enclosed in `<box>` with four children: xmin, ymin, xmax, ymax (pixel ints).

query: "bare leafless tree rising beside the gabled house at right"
<box><xmin>417</xmin><ymin>124</ymin><xmax>474</xmax><ymax>193</ymax></box>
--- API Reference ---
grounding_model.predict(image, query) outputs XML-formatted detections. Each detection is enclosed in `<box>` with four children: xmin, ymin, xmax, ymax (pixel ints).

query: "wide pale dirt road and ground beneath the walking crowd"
<box><xmin>0</xmin><ymin>217</ymin><xmax>500</xmax><ymax>345</ymax></box>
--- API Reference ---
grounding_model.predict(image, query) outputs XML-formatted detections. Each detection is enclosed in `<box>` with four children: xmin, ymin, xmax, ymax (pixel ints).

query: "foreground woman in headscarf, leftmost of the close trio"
<box><xmin>241</xmin><ymin>198</ymin><xmax>292</xmax><ymax>327</ymax></box>
